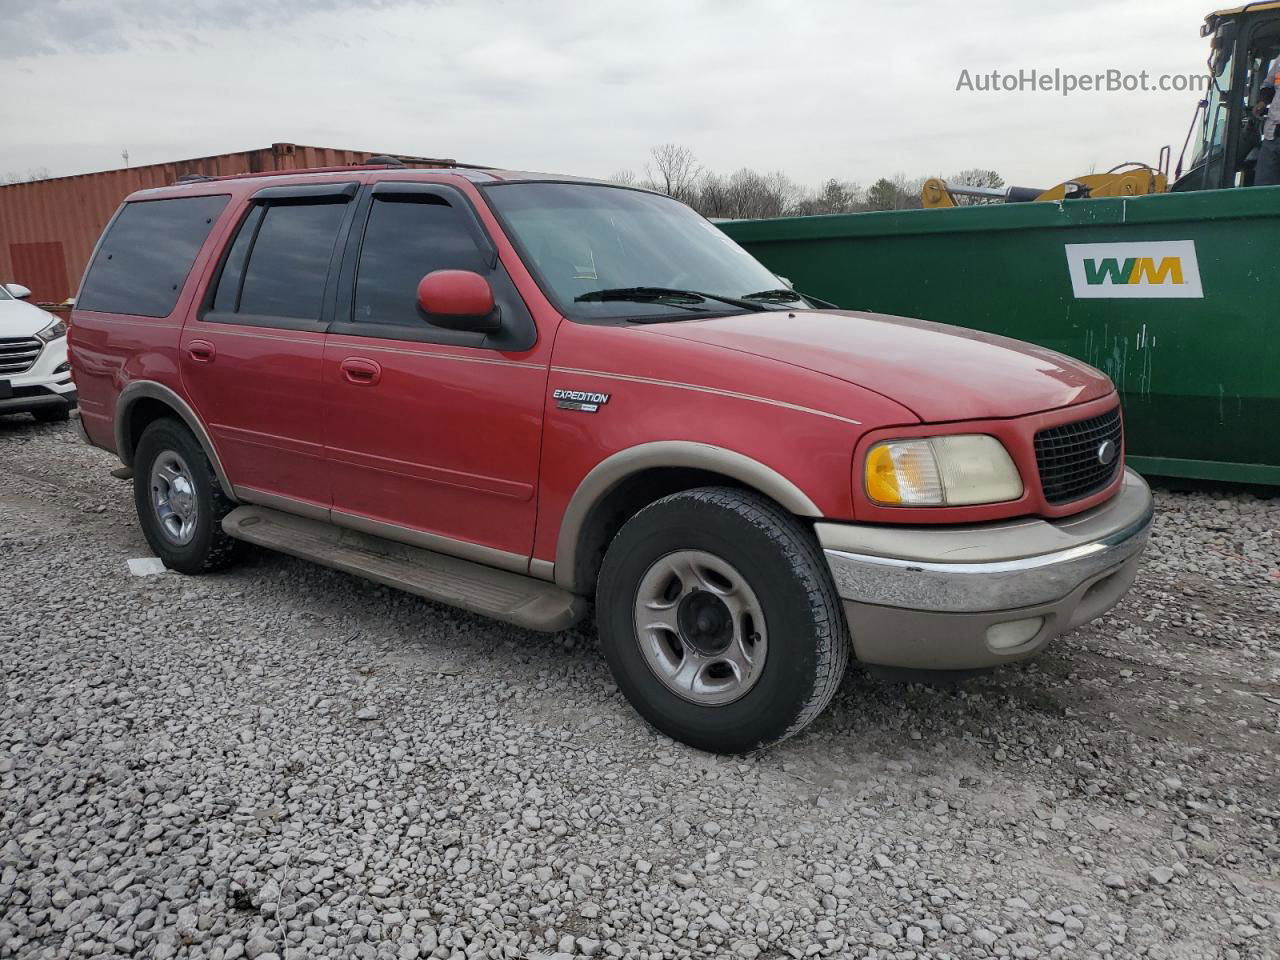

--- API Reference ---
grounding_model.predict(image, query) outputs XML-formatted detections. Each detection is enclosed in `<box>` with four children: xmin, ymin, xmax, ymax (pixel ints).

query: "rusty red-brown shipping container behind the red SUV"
<box><xmin>0</xmin><ymin>143</ymin><xmax>456</xmax><ymax>303</ymax></box>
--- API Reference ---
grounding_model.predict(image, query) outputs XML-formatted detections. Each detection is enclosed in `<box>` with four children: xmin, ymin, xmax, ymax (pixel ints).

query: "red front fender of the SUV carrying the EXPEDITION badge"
<box><xmin>534</xmin><ymin>317</ymin><xmax>919</xmax><ymax>559</ymax></box>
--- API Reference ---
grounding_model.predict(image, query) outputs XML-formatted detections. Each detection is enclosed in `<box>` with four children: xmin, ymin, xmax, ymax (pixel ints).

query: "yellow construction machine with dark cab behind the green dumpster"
<box><xmin>920</xmin><ymin>1</ymin><xmax>1280</xmax><ymax>207</ymax></box>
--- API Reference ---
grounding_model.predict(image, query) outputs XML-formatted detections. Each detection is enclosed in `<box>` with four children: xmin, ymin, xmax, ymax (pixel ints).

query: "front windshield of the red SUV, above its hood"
<box><xmin>484</xmin><ymin>183</ymin><xmax>808</xmax><ymax>320</ymax></box>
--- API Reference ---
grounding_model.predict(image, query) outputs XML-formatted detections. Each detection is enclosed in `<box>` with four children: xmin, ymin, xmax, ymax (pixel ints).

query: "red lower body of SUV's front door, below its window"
<box><xmin>317</xmin><ymin>335</ymin><xmax>547</xmax><ymax>557</ymax></box>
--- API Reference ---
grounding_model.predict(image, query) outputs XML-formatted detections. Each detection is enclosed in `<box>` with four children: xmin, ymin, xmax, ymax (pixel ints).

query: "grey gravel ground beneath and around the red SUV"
<box><xmin>0</xmin><ymin>417</ymin><xmax>1280</xmax><ymax>960</ymax></box>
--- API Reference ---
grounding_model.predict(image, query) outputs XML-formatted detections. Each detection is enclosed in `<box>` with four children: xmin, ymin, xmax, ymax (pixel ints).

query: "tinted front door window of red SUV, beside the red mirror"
<box><xmin>355</xmin><ymin>195</ymin><xmax>489</xmax><ymax>325</ymax></box>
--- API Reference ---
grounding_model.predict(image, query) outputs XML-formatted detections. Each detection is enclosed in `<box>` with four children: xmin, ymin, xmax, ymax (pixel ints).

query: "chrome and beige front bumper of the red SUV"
<box><xmin>815</xmin><ymin>470</ymin><xmax>1152</xmax><ymax>669</ymax></box>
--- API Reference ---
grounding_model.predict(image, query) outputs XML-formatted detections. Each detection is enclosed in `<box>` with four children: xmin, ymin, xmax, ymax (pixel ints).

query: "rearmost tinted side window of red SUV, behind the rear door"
<box><xmin>77</xmin><ymin>196</ymin><xmax>230</xmax><ymax>316</ymax></box>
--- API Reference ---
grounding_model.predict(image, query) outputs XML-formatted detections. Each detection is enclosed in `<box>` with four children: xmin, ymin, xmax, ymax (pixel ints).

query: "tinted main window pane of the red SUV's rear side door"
<box><xmin>238</xmin><ymin>202</ymin><xmax>347</xmax><ymax>320</ymax></box>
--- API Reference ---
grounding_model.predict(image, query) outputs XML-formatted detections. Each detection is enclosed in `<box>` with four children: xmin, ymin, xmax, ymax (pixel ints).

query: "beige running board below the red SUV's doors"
<box><xmin>223</xmin><ymin>507</ymin><xmax>588</xmax><ymax>632</ymax></box>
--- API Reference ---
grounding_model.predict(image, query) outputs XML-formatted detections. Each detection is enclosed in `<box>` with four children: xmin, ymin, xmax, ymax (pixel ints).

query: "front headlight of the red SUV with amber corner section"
<box><xmin>864</xmin><ymin>434</ymin><xmax>1023</xmax><ymax>507</ymax></box>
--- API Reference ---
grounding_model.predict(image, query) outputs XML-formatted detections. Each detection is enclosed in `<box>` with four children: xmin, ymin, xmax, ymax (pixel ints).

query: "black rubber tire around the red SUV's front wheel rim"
<box><xmin>596</xmin><ymin>488</ymin><xmax>850</xmax><ymax>754</ymax></box>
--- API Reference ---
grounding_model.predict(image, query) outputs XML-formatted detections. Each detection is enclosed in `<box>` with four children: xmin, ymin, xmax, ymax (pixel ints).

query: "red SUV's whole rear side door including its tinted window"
<box><xmin>179</xmin><ymin>183</ymin><xmax>357</xmax><ymax>513</ymax></box>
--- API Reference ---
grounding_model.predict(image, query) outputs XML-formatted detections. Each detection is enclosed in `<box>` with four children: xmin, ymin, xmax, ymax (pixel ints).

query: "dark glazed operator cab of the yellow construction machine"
<box><xmin>1171</xmin><ymin>3</ymin><xmax>1280</xmax><ymax>192</ymax></box>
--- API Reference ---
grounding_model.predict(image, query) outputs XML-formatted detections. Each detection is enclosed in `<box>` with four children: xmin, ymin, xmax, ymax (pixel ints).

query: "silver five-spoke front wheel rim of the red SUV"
<box><xmin>635</xmin><ymin>550</ymin><xmax>768</xmax><ymax>707</ymax></box>
